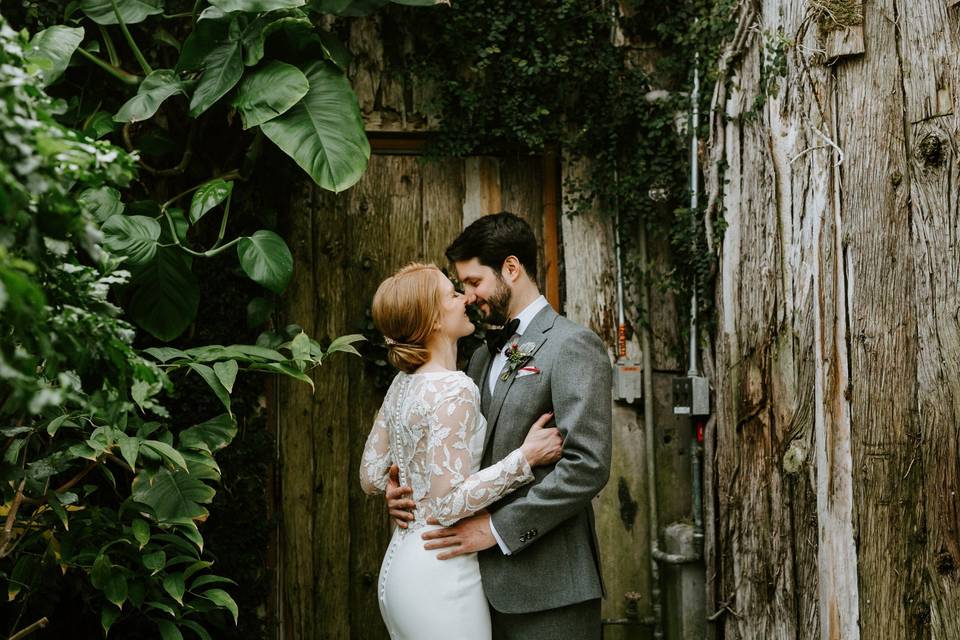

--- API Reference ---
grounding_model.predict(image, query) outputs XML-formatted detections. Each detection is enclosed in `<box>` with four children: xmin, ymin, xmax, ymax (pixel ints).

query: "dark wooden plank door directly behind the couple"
<box><xmin>277</xmin><ymin>155</ymin><xmax>559</xmax><ymax>640</ymax></box>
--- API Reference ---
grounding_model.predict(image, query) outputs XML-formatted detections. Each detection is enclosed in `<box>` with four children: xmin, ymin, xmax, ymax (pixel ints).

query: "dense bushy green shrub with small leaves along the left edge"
<box><xmin>0</xmin><ymin>18</ymin><xmax>359</xmax><ymax>639</ymax></box>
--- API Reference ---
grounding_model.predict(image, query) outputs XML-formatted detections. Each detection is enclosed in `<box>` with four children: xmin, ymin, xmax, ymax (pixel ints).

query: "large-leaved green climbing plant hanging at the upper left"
<box><xmin>17</xmin><ymin>0</ymin><xmax>446</xmax><ymax>341</ymax></box>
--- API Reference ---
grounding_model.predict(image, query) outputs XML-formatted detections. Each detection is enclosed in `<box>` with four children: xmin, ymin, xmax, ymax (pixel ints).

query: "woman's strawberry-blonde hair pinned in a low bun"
<box><xmin>372</xmin><ymin>262</ymin><xmax>443</xmax><ymax>373</ymax></box>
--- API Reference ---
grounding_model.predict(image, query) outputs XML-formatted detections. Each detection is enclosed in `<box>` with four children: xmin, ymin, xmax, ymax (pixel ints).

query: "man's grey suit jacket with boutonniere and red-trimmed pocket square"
<box><xmin>467</xmin><ymin>307</ymin><xmax>612</xmax><ymax>613</ymax></box>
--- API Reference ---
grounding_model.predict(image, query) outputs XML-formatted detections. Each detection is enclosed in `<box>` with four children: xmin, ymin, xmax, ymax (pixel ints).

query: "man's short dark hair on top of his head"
<box><xmin>446</xmin><ymin>211</ymin><xmax>537</xmax><ymax>281</ymax></box>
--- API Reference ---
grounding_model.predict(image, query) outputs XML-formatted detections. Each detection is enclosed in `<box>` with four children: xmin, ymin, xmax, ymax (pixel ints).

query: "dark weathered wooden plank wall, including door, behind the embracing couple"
<box><xmin>266</xmin><ymin>13</ymin><xmax>690</xmax><ymax>640</ymax></box>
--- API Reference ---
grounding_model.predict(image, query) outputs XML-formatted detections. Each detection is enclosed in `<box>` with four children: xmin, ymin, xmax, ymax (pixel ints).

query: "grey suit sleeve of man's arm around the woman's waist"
<box><xmin>491</xmin><ymin>331</ymin><xmax>613</xmax><ymax>555</ymax></box>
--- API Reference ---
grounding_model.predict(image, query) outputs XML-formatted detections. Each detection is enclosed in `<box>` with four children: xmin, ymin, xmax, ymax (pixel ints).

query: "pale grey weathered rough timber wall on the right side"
<box><xmin>708</xmin><ymin>0</ymin><xmax>960</xmax><ymax>640</ymax></box>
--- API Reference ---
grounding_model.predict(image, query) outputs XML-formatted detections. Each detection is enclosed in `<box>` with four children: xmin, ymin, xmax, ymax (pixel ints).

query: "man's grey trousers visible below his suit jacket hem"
<box><xmin>490</xmin><ymin>598</ymin><xmax>602</xmax><ymax>640</ymax></box>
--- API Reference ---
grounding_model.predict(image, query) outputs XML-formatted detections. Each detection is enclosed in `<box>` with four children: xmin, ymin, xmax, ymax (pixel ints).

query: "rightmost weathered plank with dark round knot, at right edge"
<box><xmin>896</xmin><ymin>3</ymin><xmax>960</xmax><ymax>638</ymax></box>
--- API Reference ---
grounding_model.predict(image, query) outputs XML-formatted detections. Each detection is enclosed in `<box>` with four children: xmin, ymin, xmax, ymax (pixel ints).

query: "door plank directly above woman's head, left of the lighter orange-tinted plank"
<box><xmin>420</xmin><ymin>158</ymin><xmax>464</xmax><ymax>267</ymax></box>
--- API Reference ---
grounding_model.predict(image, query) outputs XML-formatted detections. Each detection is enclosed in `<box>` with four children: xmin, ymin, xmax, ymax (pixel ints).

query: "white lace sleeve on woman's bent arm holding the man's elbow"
<box><xmin>428</xmin><ymin>385</ymin><xmax>533</xmax><ymax>525</ymax></box>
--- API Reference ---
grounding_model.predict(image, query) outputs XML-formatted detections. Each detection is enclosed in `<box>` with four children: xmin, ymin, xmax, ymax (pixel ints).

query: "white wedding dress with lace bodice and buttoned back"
<box><xmin>360</xmin><ymin>371</ymin><xmax>533</xmax><ymax>640</ymax></box>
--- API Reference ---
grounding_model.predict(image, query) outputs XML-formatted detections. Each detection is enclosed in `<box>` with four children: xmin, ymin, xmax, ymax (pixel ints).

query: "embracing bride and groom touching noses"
<box><xmin>360</xmin><ymin>212</ymin><xmax>612</xmax><ymax>640</ymax></box>
